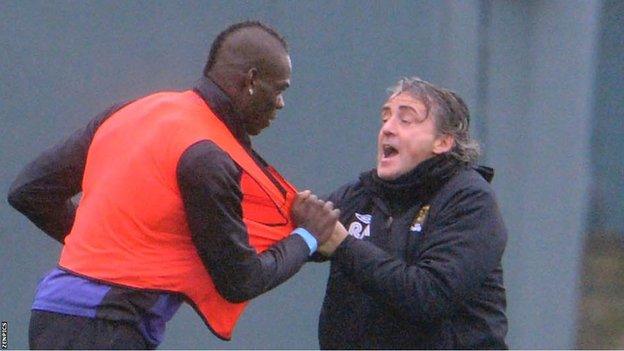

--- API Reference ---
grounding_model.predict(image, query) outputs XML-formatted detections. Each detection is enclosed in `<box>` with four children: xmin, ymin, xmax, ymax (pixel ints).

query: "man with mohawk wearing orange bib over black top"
<box><xmin>9</xmin><ymin>21</ymin><xmax>339</xmax><ymax>349</ymax></box>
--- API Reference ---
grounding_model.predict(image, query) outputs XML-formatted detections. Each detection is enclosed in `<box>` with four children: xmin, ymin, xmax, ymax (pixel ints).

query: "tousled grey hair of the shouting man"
<box><xmin>389</xmin><ymin>77</ymin><xmax>481</xmax><ymax>164</ymax></box>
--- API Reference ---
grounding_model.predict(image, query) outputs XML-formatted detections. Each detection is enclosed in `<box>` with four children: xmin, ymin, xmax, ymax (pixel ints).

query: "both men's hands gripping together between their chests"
<box><xmin>291</xmin><ymin>190</ymin><xmax>348</xmax><ymax>257</ymax></box>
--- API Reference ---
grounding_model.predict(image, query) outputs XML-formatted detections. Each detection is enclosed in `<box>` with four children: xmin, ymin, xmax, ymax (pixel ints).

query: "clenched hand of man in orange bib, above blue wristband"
<box><xmin>291</xmin><ymin>190</ymin><xmax>340</xmax><ymax>245</ymax></box>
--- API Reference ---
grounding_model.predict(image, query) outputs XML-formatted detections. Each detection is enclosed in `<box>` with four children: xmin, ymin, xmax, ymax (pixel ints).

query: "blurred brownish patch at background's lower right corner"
<box><xmin>577</xmin><ymin>233</ymin><xmax>624</xmax><ymax>349</ymax></box>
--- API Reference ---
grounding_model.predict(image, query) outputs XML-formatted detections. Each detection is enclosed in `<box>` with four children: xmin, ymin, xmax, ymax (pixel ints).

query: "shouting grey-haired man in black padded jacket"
<box><xmin>319</xmin><ymin>78</ymin><xmax>507</xmax><ymax>349</ymax></box>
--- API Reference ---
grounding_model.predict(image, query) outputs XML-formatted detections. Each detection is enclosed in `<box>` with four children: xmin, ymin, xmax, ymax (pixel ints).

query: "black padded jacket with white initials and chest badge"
<box><xmin>319</xmin><ymin>156</ymin><xmax>507</xmax><ymax>349</ymax></box>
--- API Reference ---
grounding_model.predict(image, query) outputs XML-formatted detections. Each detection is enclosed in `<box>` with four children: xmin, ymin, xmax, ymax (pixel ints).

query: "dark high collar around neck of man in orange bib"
<box><xmin>193</xmin><ymin>77</ymin><xmax>251</xmax><ymax>149</ymax></box>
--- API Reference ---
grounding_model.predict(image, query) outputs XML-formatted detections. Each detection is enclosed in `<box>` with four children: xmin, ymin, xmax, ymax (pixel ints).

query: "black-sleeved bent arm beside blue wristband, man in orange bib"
<box><xmin>177</xmin><ymin>141</ymin><xmax>310</xmax><ymax>302</ymax></box>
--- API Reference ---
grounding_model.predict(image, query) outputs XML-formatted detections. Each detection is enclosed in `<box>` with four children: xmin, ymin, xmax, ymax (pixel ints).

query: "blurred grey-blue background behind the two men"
<box><xmin>0</xmin><ymin>0</ymin><xmax>624</xmax><ymax>349</ymax></box>
